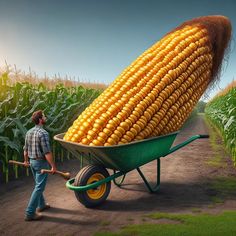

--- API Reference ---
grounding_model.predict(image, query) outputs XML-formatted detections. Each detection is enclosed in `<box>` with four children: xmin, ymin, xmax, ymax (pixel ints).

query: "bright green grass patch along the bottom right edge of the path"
<box><xmin>95</xmin><ymin>211</ymin><xmax>236</xmax><ymax>236</ymax></box>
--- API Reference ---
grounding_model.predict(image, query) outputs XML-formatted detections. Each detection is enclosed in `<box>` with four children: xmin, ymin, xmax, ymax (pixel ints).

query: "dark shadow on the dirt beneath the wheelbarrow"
<box><xmin>96</xmin><ymin>182</ymin><xmax>217</xmax><ymax>212</ymax></box>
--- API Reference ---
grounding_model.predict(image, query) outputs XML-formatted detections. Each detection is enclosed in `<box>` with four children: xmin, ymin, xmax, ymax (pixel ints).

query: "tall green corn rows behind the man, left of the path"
<box><xmin>0</xmin><ymin>72</ymin><xmax>101</xmax><ymax>182</ymax></box>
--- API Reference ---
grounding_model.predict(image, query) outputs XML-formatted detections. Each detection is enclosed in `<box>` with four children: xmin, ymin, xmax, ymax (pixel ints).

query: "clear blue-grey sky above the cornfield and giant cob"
<box><xmin>0</xmin><ymin>0</ymin><xmax>236</xmax><ymax>97</ymax></box>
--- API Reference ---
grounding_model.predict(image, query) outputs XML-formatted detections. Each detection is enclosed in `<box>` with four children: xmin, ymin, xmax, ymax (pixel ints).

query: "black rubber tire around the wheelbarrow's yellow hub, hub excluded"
<box><xmin>74</xmin><ymin>165</ymin><xmax>111</xmax><ymax>208</ymax></box>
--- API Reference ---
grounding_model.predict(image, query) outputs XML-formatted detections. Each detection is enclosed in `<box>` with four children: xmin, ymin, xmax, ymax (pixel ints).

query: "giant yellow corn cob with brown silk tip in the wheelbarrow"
<box><xmin>64</xmin><ymin>16</ymin><xmax>231</xmax><ymax>146</ymax></box>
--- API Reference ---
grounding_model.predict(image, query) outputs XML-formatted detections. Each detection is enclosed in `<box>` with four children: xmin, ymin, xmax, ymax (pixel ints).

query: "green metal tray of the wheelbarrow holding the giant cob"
<box><xmin>54</xmin><ymin>132</ymin><xmax>178</xmax><ymax>172</ymax></box>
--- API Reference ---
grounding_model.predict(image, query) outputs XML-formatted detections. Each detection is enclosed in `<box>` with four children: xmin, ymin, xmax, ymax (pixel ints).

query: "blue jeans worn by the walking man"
<box><xmin>26</xmin><ymin>160</ymin><xmax>49</xmax><ymax>216</ymax></box>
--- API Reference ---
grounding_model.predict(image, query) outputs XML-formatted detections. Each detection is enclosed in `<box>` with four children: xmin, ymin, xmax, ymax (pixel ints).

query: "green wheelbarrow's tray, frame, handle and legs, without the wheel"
<box><xmin>54</xmin><ymin>131</ymin><xmax>209</xmax><ymax>195</ymax></box>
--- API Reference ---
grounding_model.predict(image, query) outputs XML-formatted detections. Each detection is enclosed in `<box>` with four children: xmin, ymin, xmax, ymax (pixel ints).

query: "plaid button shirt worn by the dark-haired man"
<box><xmin>24</xmin><ymin>125</ymin><xmax>51</xmax><ymax>159</ymax></box>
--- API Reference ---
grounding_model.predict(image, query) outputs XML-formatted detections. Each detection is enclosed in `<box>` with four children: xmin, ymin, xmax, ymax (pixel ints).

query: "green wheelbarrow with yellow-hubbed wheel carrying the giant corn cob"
<box><xmin>54</xmin><ymin>131</ymin><xmax>209</xmax><ymax>208</ymax></box>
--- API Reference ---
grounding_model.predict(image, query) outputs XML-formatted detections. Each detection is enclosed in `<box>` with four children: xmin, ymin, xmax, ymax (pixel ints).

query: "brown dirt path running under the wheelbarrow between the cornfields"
<box><xmin>0</xmin><ymin>116</ymin><xmax>236</xmax><ymax>236</ymax></box>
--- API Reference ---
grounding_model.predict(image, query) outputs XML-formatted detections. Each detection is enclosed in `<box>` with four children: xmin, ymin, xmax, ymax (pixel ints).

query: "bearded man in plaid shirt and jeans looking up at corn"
<box><xmin>24</xmin><ymin>110</ymin><xmax>56</xmax><ymax>221</ymax></box>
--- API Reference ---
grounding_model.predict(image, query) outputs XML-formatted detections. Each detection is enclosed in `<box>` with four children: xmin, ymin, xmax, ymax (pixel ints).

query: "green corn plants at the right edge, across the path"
<box><xmin>205</xmin><ymin>82</ymin><xmax>236</xmax><ymax>164</ymax></box>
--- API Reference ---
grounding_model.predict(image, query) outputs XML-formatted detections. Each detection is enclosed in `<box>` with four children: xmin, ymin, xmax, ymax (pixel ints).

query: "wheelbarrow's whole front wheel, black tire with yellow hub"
<box><xmin>74</xmin><ymin>165</ymin><xmax>111</xmax><ymax>208</ymax></box>
